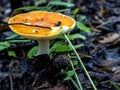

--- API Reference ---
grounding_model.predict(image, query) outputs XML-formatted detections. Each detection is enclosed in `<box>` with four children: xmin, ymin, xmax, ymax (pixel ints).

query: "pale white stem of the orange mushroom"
<box><xmin>37</xmin><ymin>40</ymin><xmax>49</xmax><ymax>55</ymax></box>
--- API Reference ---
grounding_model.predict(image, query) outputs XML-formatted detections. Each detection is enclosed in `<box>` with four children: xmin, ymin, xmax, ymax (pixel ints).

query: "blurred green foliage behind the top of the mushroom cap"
<box><xmin>16</xmin><ymin>0</ymin><xmax>74</xmax><ymax>12</ymax></box>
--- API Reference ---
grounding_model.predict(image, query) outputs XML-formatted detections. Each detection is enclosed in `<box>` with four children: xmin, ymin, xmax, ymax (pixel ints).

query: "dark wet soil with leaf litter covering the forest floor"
<box><xmin>0</xmin><ymin>0</ymin><xmax>120</xmax><ymax>90</ymax></box>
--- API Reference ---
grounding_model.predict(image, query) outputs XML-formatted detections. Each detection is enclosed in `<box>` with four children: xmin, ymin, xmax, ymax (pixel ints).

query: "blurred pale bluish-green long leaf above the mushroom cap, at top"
<box><xmin>48</xmin><ymin>1</ymin><xmax>74</xmax><ymax>7</ymax></box>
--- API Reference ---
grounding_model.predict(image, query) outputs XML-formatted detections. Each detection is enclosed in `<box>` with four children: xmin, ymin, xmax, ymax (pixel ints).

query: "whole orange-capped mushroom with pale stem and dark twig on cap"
<box><xmin>8</xmin><ymin>11</ymin><xmax>76</xmax><ymax>55</ymax></box>
